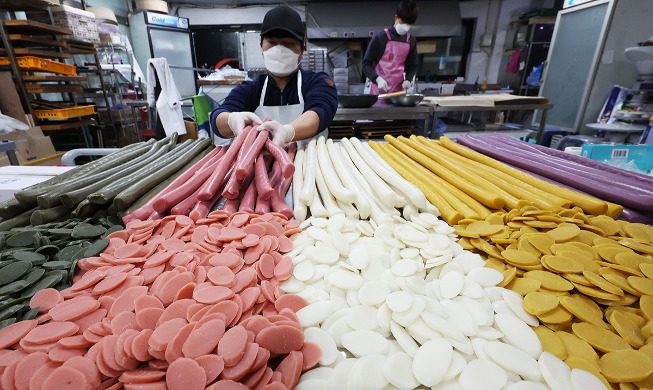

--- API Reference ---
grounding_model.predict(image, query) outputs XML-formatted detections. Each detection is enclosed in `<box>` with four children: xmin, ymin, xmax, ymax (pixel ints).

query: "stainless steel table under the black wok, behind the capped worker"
<box><xmin>333</xmin><ymin>103</ymin><xmax>432</xmax><ymax>135</ymax></box>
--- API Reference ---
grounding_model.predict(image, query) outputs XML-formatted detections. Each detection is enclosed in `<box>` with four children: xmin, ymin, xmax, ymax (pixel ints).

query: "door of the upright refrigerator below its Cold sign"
<box><xmin>149</xmin><ymin>28</ymin><xmax>197</xmax><ymax>98</ymax></box>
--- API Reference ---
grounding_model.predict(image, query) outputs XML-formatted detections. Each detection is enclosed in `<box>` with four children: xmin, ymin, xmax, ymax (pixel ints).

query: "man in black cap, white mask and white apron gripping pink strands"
<box><xmin>211</xmin><ymin>6</ymin><xmax>338</xmax><ymax>145</ymax></box>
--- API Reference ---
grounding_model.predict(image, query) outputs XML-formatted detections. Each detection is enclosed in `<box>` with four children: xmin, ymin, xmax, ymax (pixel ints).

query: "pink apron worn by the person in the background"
<box><xmin>370</xmin><ymin>28</ymin><xmax>410</xmax><ymax>95</ymax></box>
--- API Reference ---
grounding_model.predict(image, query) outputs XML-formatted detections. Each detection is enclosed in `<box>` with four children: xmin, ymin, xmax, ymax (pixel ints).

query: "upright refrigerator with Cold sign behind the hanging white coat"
<box><xmin>129</xmin><ymin>11</ymin><xmax>197</xmax><ymax>98</ymax></box>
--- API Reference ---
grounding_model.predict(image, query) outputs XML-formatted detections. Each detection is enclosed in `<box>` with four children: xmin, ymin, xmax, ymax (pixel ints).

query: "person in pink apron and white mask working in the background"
<box><xmin>363</xmin><ymin>0</ymin><xmax>418</xmax><ymax>94</ymax></box>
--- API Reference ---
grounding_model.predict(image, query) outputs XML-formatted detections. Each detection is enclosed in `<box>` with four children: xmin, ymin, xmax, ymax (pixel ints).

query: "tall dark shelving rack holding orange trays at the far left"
<box><xmin>0</xmin><ymin>0</ymin><xmax>109</xmax><ymax>150</ymax></box>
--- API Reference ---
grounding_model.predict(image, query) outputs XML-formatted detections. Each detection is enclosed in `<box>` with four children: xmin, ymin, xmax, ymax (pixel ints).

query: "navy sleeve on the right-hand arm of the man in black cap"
<box><xmin>302</xmin><ymin>71</ymin><xmax>338</xmax><ymax>133</ymax></box>
